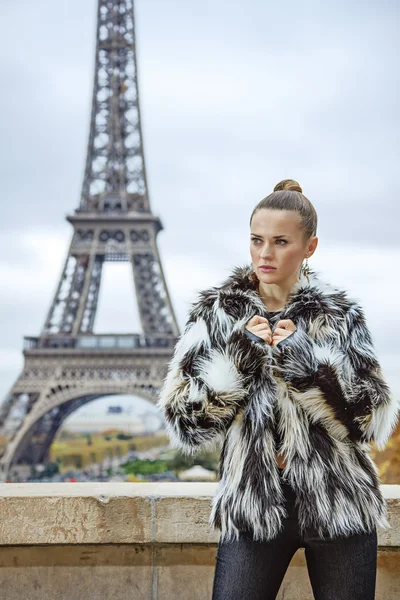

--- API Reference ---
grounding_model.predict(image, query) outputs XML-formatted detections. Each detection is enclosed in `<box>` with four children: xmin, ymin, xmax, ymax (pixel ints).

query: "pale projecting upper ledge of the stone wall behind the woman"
<box><xmin>0</xmin><ymin>482</ymin><xmax>400</xmax><ymax>547</ymax></box>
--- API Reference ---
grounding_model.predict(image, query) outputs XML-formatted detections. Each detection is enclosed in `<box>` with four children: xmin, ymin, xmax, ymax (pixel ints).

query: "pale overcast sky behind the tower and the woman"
<box><xmin>0</xmin><ymin>0</ymin><xmax>400</xmax><ymax>418</ymax></box>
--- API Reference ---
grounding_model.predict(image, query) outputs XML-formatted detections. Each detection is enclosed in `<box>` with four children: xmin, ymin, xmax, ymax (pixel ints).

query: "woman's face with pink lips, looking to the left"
<box><xmin>250</xmin><ymin>208</ymin><xmax>318</xmax><ymax>283</ymax></box>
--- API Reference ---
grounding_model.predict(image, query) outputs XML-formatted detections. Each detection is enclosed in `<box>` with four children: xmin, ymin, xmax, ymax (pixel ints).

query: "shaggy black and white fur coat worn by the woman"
<box><xmin>157</xmin><ymin>266</ymin><xmax>399</xmax><ymax>540</ymax></box>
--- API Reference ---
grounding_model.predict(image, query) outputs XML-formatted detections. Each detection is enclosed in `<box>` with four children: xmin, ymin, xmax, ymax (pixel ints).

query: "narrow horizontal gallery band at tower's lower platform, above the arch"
<box><xmin>24</xmin><ymin>334</ymin><xmax>177</xmax><ymax>350</ymax></box>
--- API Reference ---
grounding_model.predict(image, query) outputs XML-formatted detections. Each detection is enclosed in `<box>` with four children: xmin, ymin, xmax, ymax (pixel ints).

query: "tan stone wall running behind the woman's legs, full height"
<box><xmin>0</xmin><ymin>483</ymin><xmax>400</xmax><ymax>600</ymax></box>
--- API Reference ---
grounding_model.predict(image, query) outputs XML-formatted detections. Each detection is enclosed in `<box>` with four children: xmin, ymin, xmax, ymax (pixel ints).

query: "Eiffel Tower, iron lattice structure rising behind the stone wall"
<box><xmin>0</xmin><ymin>0</ymin><xmax>179</xmax><ymax>480</ymax></box>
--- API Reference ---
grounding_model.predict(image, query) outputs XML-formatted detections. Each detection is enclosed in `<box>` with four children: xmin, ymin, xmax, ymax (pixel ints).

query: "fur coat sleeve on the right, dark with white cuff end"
<box><xmin>277</xmin><ymin>303</ymin><xmax>400</xmax><ymax>450</ymax></box>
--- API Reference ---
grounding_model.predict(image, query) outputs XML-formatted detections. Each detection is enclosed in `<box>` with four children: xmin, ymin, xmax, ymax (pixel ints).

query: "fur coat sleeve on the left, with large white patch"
<box><xmin>157</xmin><ymin>301</ymin><xmax>271</xmax><ymax>454</ymax></box>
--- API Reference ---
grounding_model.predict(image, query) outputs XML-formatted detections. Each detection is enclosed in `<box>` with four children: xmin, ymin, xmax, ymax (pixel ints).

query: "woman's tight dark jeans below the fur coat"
<box><xmin>212</xmin><ymin>472</ymin><xmax>378</xmax><ymax>600</ymax></box>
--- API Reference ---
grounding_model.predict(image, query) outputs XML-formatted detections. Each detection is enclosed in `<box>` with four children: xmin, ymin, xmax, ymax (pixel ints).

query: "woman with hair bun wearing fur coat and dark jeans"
<box><xmin>158</xmin><ymin>180</ymin><xmax>399</xmax><ymax>600</ymax></box>
